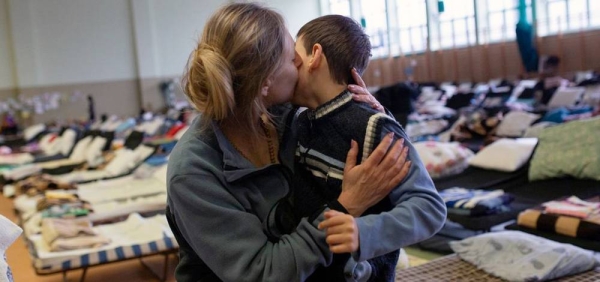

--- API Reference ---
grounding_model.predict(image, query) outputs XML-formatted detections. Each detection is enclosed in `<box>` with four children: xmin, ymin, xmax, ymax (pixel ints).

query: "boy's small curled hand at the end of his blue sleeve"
<box><xmin>319</xmin><ymin>210</ymin><xmax>360</xmax><ymax>254</ymax></box>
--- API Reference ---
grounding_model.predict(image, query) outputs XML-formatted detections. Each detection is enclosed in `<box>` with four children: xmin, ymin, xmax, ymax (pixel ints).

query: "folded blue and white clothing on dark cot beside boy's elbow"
<box><xmin>440</xmin><ymin>187</ymin><xmax>514</xmax><ymax>216</ymax></box>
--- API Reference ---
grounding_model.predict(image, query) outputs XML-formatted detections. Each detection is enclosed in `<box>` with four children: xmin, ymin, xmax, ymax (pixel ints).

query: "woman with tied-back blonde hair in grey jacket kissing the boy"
<box><xmin>167</xmin><ymin>4</ymin><xmax>408</xmax><ymax>281</ymax></box>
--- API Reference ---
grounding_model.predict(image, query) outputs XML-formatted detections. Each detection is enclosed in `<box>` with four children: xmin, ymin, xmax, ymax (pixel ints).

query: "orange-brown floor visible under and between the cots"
<box><xmin>0</xmin><ymin>195</ymin><xmax>441</xmax><ymax>282</ymax></box>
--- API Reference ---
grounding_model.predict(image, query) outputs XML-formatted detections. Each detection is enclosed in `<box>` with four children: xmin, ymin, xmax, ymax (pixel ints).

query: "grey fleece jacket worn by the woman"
<box><xmin>167</xmin><ymin>107</ymin><xmax>370</xmax><ymax>281</ymax></box>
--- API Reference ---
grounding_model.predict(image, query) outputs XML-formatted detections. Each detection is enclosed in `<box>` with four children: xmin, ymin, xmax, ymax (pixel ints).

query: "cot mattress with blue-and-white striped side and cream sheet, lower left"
<box><xmin>28</xmin><ymin>214</ymin><xmax>179</xmax><ymax>274</ymax></box>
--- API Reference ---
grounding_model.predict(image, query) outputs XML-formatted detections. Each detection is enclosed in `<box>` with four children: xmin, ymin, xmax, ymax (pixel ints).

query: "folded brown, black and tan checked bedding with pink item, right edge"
<box><xmin>517</xmin><ymin>196</ymin><xmax>600</xmax><ymax>241</ymax></box>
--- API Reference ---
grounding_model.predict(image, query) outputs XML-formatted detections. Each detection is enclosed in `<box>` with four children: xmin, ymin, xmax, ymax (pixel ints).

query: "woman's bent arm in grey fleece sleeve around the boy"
<box><xmin>169</xmin><ymin>173</ymin><xmax>331</xmax><ymax>281</ymax></box>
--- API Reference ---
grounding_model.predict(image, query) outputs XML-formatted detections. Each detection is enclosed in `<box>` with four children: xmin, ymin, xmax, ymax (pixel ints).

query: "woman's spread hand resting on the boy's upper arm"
<box><xmin>338</xmin><ymin>133</ymin><xmax>411</xmax><ymax>216</ymax></box>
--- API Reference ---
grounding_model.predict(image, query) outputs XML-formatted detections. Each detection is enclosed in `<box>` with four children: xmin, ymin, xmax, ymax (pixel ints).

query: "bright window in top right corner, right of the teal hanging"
<box><xmin>537</xmin><ymin>0</ymin><xmax>600</xmax><ymax>36</ymax></box>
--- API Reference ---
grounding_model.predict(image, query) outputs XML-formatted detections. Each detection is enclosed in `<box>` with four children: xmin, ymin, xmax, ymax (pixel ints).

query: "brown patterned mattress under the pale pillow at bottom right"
<box><xmin>396</xmin><ymin>254</ymin><xmax>600</xmax><ymax>282</ymax></box>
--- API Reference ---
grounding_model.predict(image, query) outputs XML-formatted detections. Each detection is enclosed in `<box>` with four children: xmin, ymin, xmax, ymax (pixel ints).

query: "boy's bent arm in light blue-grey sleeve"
<box><xmin>353</xmin><ymin>116</ymin><xmax>446</xmax><ymax>261</ymax></box>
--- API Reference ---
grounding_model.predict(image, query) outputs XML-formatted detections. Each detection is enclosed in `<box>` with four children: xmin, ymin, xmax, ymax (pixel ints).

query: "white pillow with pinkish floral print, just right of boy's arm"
<box><xmin>413</xmin><ymin>141</ymin><xmax>473</xmax><ymax>178</ymax></box>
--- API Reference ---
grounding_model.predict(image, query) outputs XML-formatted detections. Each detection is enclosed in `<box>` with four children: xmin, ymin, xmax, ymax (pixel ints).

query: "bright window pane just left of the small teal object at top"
<box><xmin>390</xmin><ymin>0</ymin><xmax>428</xmax><ymax>56</ymax></box>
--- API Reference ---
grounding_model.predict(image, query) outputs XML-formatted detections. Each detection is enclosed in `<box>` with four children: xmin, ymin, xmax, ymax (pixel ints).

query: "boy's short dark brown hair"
<box><xmin>297</xmin><ymin>15</ymin><xmax>371</xmax><ymax>84</ymax></box>
